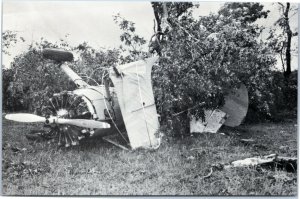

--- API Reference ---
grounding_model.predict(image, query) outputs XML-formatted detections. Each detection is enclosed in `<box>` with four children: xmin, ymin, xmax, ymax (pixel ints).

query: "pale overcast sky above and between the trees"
<box><xmin>2</xmin><ymin>0</ymin><xmax>298</xmax><ymax>70</ymax></box>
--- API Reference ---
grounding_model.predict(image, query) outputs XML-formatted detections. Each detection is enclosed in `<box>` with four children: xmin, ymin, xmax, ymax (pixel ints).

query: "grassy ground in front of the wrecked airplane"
<box><xmin>2</xmin><ymin>116</ymin><xmax>297</xmax><ymax>196</ymax></box>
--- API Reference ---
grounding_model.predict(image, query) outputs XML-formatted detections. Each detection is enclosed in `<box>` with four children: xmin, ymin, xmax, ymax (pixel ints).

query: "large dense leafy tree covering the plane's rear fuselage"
<box><xmin>148</xmin><ymin>3</ymin><xmax>275</xmax><ymax>130</ymax></box>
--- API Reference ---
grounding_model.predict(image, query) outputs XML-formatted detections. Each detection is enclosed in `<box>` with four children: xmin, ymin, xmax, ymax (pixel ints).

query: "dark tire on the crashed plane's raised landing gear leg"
<box><xmin>43</xmin><ymin>48</ymin><xmax>73</xmax><ymax>62</ymax></box>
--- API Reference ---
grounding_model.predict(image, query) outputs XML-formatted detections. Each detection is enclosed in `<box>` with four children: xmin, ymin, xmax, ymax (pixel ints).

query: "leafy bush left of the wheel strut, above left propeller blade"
<box><xmin>4</xmin><ymin>39</ymin><xmax>75</xmax><ymax>112</ymax></box>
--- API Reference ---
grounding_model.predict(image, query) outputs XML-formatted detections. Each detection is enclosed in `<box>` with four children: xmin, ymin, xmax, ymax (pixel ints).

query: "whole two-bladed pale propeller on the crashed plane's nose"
<box><xmin>5</xmin><ymin>113</ymin><xmax>110</xmax><ymax>129</ymax></box>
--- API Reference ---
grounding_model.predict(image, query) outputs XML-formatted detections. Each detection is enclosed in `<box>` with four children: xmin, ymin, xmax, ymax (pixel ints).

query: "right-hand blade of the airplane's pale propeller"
<box><xmin>55</xmin><ymin>118</ymin><xmax>110</xmax><ymax>129</ymax></box>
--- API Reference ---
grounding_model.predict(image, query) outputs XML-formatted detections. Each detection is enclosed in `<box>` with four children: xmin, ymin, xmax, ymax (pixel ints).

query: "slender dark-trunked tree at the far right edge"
<box><xmin>267</xmin><ymin>2</ymin><xmax>298</xmax><ymax>112</ymax></box>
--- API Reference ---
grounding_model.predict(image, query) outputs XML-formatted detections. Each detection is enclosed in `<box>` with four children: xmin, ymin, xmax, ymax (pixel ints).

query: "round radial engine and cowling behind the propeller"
<box><xmin>33</xmin><ymin>85</ymin><xmax>123</xmax><ymax>147</ymax></box>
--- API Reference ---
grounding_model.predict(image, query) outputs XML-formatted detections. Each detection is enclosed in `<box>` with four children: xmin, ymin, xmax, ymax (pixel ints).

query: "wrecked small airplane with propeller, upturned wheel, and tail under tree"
<box><xmin>5</xmin><ymin>49</ymin><xmax>248</xmax><ymax>149</ymax></box>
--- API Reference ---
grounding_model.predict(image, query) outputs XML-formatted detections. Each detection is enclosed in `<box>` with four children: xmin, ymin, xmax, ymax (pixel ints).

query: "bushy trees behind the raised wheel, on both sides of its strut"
<box><xmin>3</xmin><ymin>35</ymin><xmax>119</xmax><ymax>114</ymax></box>
